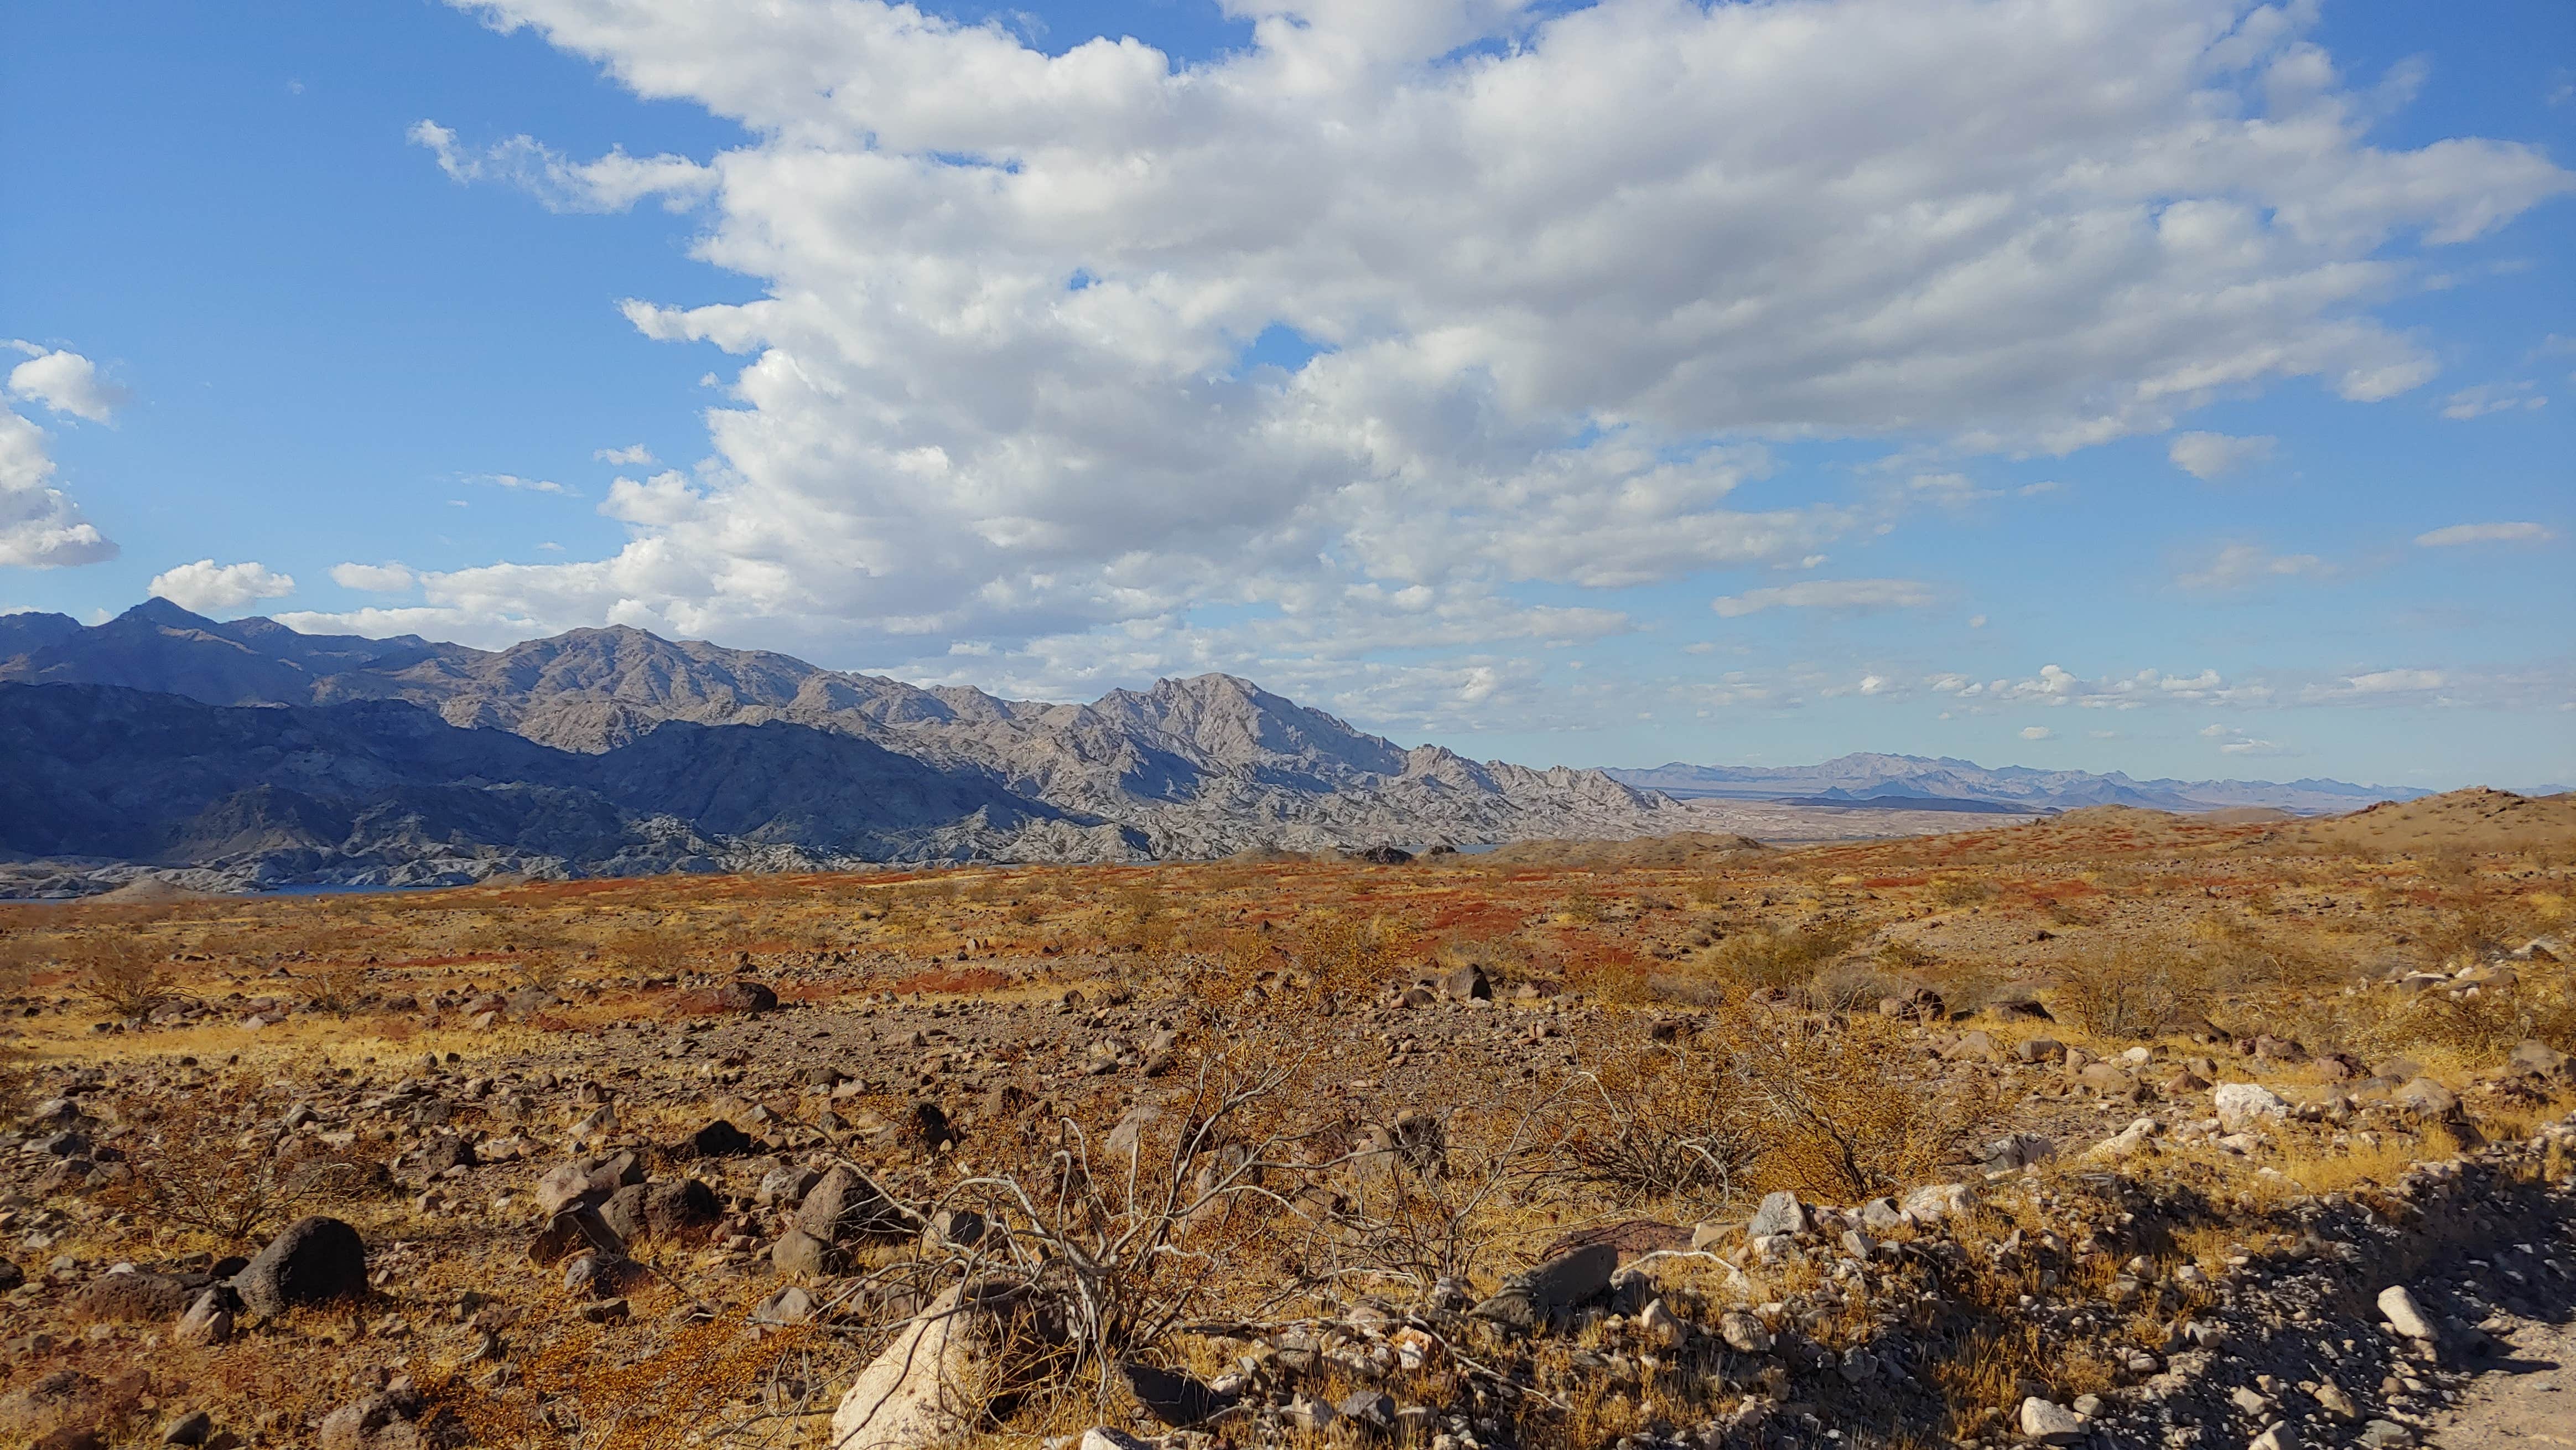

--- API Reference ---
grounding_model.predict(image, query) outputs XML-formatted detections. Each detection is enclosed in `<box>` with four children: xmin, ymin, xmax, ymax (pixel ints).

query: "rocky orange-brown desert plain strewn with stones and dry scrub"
<box><xmin>0</xmin><ymin>798</ymin><xmax>2576</xmax><ymax>1450</ymax></box>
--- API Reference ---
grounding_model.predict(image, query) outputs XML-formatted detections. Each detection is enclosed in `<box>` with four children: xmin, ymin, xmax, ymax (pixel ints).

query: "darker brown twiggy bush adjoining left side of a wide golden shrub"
<box><xmin>1556</xmin><ymin>1048</ymin><xmax>1754</xmax><ymax>1203</ymax></box>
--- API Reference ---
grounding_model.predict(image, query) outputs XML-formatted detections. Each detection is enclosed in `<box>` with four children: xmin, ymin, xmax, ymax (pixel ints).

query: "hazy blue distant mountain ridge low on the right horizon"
<box><xmin>1607</xmin><ymin>752</ymin><xmax>2432</xmax><ymax>814</ymax></box>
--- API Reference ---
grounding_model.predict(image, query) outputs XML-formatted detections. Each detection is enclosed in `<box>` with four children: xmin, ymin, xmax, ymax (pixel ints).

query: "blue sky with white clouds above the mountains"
<box><xmin>0</xmin><ymin>0</ymin><xmax>2576</xmax><ymax>788</ymax></box>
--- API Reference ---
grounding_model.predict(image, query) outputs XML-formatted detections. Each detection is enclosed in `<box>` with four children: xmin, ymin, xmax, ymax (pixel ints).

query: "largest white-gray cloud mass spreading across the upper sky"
<box><xmin>373</xmin><ymin>0</ymin><xmax>2576</xmax><ymax>667</ymax></box>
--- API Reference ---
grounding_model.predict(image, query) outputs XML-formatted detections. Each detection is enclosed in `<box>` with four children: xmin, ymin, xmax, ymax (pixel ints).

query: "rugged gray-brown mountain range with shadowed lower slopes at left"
<box><xmin>0</xmin><ymin>600</ymin><xmax>1690</xmax><ymax>883</ymax></box>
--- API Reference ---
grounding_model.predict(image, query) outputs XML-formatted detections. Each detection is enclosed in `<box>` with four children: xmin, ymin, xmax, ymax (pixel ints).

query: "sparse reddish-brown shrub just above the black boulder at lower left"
<box><xmin>106</xmin><ymin>1082</ymin><xmax>389</xmax><ymax>1246</ymax></box>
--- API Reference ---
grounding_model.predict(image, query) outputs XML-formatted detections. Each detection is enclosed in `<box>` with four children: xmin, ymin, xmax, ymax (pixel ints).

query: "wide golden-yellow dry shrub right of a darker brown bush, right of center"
<box><xmin>1703</xmin><ymin>1012</ymin><xmax>1996</xmax><ymax>1203</ymax></box>
